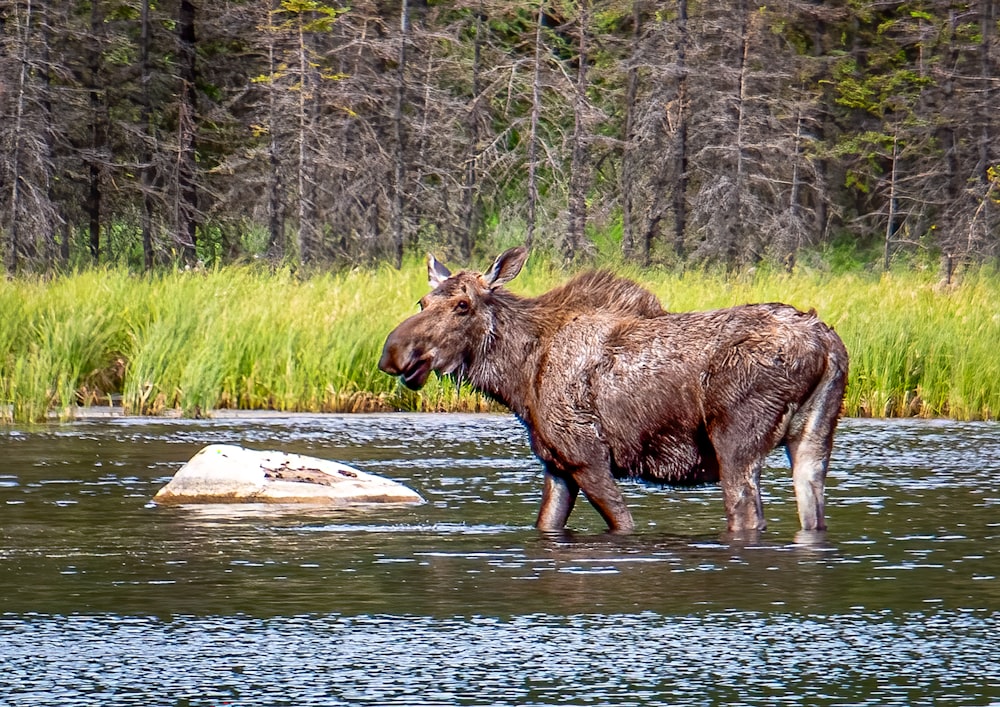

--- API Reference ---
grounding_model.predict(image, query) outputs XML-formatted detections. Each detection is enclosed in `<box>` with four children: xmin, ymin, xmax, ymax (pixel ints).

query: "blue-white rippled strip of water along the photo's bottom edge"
<box><xmin>0</xmin><ymin>610</ymin><xmax>1000</xmax><ymax>707</ymax></box>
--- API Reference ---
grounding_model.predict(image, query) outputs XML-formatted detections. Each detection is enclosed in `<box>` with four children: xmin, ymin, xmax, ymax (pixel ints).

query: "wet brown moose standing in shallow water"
<box><xmin>379</xmin><ymin>246</ymin><xmax>848</xmax><ymax>533</ymax></box>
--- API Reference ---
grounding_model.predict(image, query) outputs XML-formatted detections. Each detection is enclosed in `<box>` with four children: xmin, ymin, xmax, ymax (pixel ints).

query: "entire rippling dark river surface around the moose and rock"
<box><xmin>0</xmin><ymin>415</ymin><xmax>1000</xmax><ymax>707</ymax></box>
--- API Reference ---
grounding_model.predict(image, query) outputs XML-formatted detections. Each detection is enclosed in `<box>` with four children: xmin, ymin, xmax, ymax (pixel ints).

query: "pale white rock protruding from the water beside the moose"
<box><xmin>153</xmin><ymin>444</ymin><xmax>424</xmax><ymax>506</ymax></box>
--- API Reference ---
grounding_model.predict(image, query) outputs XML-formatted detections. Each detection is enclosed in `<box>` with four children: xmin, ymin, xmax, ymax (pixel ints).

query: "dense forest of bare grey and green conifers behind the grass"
<box><xmin>0</xmin><ymin>0</ymin><xmax>1000</xmax><ymax>279</ymax></box>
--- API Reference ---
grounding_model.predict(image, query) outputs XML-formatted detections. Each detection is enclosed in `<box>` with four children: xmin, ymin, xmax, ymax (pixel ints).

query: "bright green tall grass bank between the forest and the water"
<box><xmin>0</xmin><ymin>260</ymin><xmax>1000</xmax><ymax>421</ymax></box>
